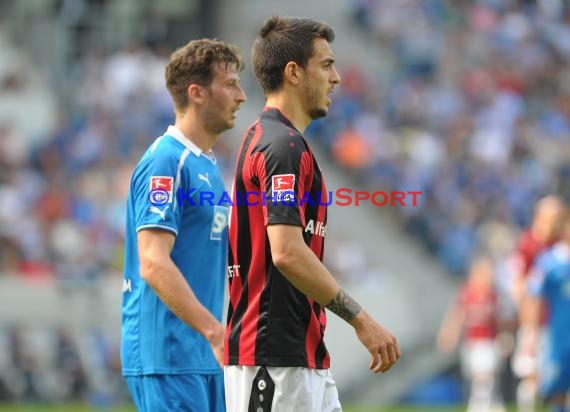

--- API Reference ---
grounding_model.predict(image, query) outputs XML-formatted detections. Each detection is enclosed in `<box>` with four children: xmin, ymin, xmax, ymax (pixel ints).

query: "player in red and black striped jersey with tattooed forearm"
<box><xmin>224</xmin><ymin>16</ymin><xmax>400</xmax><ymax>412</ymax></box>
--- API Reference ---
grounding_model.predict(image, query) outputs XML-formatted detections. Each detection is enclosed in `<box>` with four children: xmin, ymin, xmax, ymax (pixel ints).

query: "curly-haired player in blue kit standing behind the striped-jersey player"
<box><xmin>121</xmin><ymin>39</ymin><xmax>246</xmax><ymax>412</ymax></box>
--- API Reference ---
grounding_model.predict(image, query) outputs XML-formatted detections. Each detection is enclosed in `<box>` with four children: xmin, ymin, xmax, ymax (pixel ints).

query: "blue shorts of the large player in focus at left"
<box><xmin>125</xmin><ymin>373</ymin><xmax>226</xmax><ymax>412</ymax></box>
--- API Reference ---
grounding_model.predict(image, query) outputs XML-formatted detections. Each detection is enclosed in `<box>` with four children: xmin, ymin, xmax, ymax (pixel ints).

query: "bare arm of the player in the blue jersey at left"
<box><xmin>137</xmin><ymin>229</ymin><xmax>225</xmax><ymax>366</ymax></box>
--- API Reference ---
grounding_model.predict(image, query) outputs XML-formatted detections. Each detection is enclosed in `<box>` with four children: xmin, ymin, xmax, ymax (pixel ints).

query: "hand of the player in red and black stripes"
<box><xmin>350</xmin><ymin>310</ymin><xmax>400</xmax><ymax>373</ymax></box>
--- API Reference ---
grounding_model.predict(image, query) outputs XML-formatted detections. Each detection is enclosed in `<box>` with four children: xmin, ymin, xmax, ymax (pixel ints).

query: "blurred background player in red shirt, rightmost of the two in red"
<box><xmin>512</xmin><ymin>195</ymin><xmax>565</xmax><ymax>412</ymax></box>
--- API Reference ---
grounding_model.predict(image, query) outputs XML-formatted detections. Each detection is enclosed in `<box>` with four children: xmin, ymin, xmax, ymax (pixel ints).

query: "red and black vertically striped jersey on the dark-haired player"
<box><xmin>224</xmin><ymin>107</ymin><xmax>330</xmax><ymax>369</ymax></box>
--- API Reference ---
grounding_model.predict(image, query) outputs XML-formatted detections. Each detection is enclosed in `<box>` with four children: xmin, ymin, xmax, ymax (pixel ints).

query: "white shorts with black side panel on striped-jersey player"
<box><xmin>224</xmin><ymin>365</ymin><xmax>342</xmax><ymax>412</ymax></box>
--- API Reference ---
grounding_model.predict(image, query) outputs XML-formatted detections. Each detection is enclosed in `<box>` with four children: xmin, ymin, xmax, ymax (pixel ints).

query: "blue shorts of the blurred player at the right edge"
<box><xmin>540</xmin><ymin>350</ymin><xmax>570</xmax><ymax>398</ymax></box>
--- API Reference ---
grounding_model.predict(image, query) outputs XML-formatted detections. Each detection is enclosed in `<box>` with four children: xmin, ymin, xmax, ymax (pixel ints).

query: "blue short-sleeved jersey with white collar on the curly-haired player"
<box><xmin>121</xmin><ymin>126</ymin><xmax>228</xmax><ymax>376</ymax></box>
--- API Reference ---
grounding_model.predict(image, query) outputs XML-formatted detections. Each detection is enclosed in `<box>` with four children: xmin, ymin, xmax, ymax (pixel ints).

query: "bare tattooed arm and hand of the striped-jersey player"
<box><xmin>267</xmin><ymin>225</ymin><xmax>400</xmax><ymax>373</ymax></box>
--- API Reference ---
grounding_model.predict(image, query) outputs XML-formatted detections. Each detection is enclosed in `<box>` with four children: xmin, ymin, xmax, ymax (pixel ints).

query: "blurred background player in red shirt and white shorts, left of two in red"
<box><xmin>437</xmin><ymin>257</ymin><xmax>504</xmax><ymax>412</ymax></box>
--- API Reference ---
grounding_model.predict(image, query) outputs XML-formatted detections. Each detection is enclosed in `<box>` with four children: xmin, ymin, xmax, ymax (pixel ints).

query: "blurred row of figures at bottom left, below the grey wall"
<box><xmin>0</xmin><ymin>325</ymin><xmax>125</xmax><ymax>408</ymax></box>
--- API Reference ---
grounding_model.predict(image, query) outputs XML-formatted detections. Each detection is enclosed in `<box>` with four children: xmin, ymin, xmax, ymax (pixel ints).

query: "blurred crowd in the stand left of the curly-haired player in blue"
<box><xmin>0</xmin><ymin>39</ymin><xmax>173</xmax><ymax>280</ymax></box>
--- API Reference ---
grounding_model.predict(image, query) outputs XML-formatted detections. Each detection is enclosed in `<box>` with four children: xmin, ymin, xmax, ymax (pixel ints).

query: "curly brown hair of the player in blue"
<box><xmin>164</xmin><ymin>39</ymin><xmax>244</xmax><ymax>110</ymax></box>
